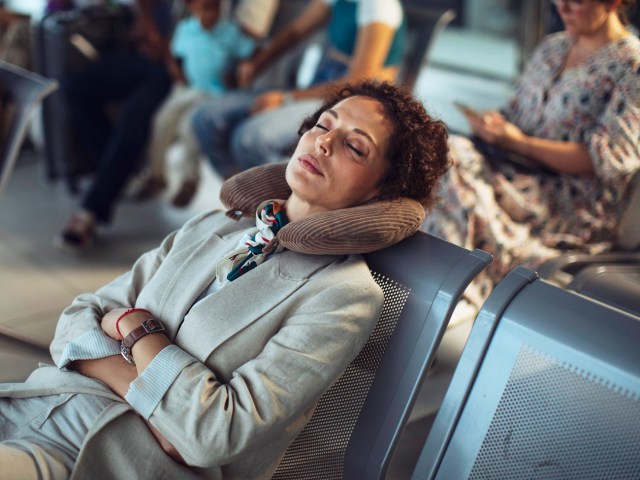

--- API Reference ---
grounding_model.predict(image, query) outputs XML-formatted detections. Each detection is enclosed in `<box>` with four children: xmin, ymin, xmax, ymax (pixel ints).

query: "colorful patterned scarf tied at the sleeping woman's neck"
<box><xmin>216</xmin><ymin>200</ymin><xmax>289</xmax><ymax>282</ymax></box>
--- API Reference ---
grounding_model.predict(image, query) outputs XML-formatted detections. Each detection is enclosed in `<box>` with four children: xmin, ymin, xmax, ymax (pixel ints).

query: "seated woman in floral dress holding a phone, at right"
<box><xmin>421</xmin><ymin>0</ymin><xmax>640</xmax><ymax>312</ymax></box>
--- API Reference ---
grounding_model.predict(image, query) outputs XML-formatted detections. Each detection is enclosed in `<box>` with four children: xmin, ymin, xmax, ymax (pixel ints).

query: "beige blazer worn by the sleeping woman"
<box><xmin>0</xmin><ymin>212</ymin><xmax>383</xmax><ymax>480</ymax></box>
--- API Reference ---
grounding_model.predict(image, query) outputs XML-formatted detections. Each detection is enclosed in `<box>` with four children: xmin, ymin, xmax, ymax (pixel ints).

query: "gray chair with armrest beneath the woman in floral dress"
<box><xmin>539</xmin><ymin>171</ymin><xmax>640</xmax><ymax>315</ymax></box>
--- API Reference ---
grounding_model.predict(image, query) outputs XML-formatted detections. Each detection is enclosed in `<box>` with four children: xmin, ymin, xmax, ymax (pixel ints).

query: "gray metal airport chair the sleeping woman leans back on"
<box><xmin>273</xmin><ymin>232</ymin><xmax>491</xmax><ymax>480</ymax></box>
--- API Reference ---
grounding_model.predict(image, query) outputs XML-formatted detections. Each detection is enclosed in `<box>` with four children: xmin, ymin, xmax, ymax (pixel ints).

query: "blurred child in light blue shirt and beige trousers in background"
<box><xmin>137</xmin><ymin>0</ymin><xmax>255</xmax><ymax>207</ymax></box>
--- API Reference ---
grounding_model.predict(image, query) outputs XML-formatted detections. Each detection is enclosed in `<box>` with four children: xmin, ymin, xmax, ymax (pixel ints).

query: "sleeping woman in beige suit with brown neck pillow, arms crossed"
<box><xmin>0</xmin><ymin>82</ymin><xmax>448</xmax><ymax>480</ymax></box>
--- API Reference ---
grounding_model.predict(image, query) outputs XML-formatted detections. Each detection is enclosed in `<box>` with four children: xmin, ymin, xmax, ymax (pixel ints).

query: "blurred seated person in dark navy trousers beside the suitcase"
<box><xmin>56</xmin><ymin>0</ymin><xmax>172</xmax><ymax>249</ymax></box>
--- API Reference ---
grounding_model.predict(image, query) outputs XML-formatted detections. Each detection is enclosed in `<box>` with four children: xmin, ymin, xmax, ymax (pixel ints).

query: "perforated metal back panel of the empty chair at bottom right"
<box><xmin>459</xmin><ymin>344</ymin><xmax>640</xmax><ymax>480</ymax></box>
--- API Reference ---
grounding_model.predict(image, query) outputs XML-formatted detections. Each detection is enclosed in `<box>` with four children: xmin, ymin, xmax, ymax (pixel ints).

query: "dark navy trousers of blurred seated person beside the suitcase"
<box><xmin>62</xmin><ymin>50</ymin><xmax>171</xmax><ymax>222</ymax></box>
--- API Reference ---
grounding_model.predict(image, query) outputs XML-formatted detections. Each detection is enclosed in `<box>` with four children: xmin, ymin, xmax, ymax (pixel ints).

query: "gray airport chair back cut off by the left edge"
<box><xmin>0</xmin><ymin>61</ymin><xmax>57</xmax><ymax>202</ymax></box>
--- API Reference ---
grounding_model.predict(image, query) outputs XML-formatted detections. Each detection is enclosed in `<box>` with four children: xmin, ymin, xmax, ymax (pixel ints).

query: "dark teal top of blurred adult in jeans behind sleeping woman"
<box><xmin>327</xmin><ymin>0</ymin><xmax>407</xmax><ymax>67</ymax></box>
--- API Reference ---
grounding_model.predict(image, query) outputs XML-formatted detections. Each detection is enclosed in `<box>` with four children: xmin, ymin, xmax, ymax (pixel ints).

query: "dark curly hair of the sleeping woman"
<box><xmin>298</xmin><ymin>80</ymin><xmax>449</xmax><ymax>208</ymax></box>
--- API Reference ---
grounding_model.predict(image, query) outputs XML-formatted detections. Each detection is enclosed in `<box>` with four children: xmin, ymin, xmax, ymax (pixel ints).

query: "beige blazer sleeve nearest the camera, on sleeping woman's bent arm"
<box><xmin>139</xmin><ymin>261</ymin><xmax>384</xmax><ymax>467</ymax></box>
